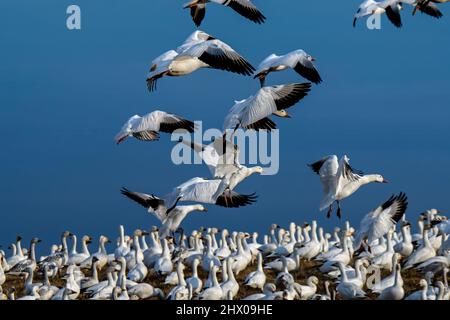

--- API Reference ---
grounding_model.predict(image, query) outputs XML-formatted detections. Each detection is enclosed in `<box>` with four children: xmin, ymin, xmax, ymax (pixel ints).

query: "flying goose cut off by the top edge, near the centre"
<box><xmin>184</xmin><ymin>0</ymin><xmax>266</xmax><ymax>27</ymax></box>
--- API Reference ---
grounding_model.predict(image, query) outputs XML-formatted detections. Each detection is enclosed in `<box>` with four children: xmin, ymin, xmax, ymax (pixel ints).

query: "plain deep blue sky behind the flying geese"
<box><xmin>0</xmin><ymin>0</ymin><xmax>450</xmax><ymax>248</ymax></box>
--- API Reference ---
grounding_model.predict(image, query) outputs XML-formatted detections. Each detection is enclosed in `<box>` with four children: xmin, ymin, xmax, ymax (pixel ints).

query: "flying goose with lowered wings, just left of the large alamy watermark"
<box><xmin>115</xmin><ymin>110</ymin><xmax>195</xmax><ymax>144</ymax></box>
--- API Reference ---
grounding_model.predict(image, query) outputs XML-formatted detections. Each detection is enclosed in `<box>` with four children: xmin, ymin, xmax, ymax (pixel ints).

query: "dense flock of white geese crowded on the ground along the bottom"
<box><xmin>0</xmin><ymin>208</ymin><xmax>450</xmax><ymax>300</ymax></box>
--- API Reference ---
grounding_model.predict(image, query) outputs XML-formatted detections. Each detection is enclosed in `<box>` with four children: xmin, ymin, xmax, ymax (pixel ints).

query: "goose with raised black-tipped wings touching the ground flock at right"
<box><xmin>355</xmin><ymin>192</ymin><xmax>408</xmax><ymax>247</ymax></box>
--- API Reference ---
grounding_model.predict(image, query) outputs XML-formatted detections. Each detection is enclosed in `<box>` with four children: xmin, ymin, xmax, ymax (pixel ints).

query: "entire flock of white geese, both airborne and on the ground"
<box><xmin>0</xmin><ymin>0</ymin><xmax>450</xmax><ymax>300</ymax></box>
